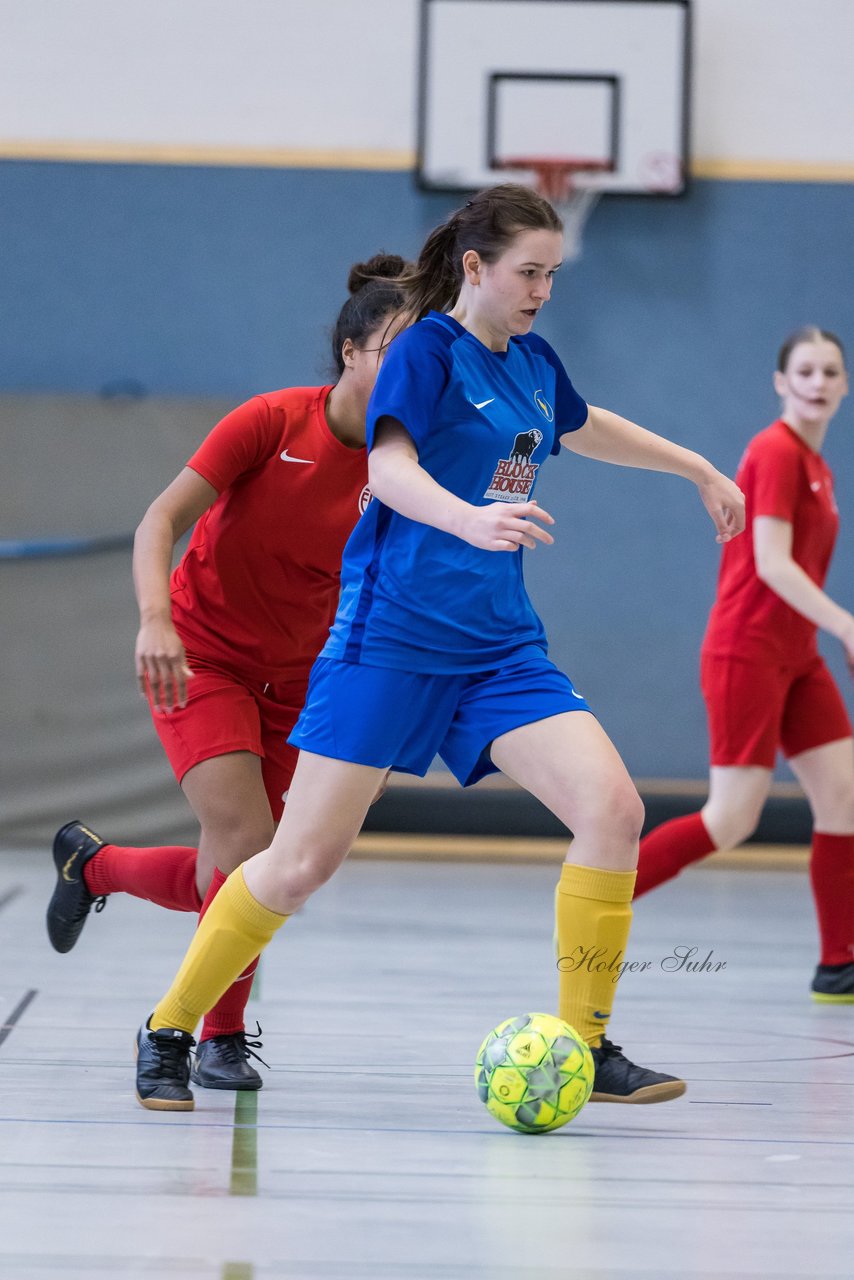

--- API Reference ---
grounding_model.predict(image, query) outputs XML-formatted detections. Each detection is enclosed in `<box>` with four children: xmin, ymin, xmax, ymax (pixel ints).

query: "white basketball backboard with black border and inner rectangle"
<box><xmin>417</xmin><ymin>0</ymin><xmax>690</xmax><ymax>196</ymax></box>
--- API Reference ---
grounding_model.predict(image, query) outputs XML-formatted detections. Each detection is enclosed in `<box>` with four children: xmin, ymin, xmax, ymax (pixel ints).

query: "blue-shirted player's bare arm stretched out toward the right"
<box><xmin>561</xmin><ymin>404</ymin><xmax>744</xmax><ymax>543</ymax></box>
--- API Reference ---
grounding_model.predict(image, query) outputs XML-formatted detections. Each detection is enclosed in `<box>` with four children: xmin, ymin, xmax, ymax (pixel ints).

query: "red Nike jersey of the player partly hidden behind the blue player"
<box><xmin>172</xmin><ymin>387</ymin><xmax>370</xmax><ymax>684</ymax></box>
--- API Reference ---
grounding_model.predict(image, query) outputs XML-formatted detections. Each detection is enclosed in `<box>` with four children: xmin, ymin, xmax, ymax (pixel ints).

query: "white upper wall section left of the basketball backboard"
<box><xmin>0</xmin><ymin>0</ymin><xmax>417</xmax><ymax>150</ymax></box>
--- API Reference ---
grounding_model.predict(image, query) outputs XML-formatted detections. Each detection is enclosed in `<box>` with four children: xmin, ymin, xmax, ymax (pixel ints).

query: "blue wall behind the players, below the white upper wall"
<box><xmin>0</xmin><ymin>161</ymin><xmax>854</xmax><ymax>777</ymax></box>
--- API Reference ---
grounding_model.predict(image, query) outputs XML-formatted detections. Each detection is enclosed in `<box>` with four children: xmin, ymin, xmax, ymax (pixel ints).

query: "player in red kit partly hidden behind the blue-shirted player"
<box><xmin>47</xmin><ymin>247</ymin><xmax>406</xmax><ymax>1089</ymax></box>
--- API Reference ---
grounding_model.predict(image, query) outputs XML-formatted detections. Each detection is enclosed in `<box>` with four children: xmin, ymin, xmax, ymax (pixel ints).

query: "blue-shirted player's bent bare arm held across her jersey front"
<box><xmin>367</xmin><ymin>417</ymin><xmax>554</xmax><ymax>552</ymax></box>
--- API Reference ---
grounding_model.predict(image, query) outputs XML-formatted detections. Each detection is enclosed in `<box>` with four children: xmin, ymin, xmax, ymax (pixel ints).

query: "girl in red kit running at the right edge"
<box><xmin>635</xmin><ymin>328</ymin><xmax>854</xmax><ymax>1004</ymax></box>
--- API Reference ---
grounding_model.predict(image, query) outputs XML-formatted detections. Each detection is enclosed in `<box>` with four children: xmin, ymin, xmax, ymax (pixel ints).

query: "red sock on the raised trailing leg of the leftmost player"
<box><xmin>83</xmin><ymin>845</ymin><xmax>201</xmax><ymax>911</ymax></box>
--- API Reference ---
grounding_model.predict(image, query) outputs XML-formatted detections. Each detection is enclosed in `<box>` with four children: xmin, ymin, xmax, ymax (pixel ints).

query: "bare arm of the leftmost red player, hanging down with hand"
<box><xmin>133</xmin><ymin>467</ymin><xmax>216</xmax><ymax>710</ymax></box>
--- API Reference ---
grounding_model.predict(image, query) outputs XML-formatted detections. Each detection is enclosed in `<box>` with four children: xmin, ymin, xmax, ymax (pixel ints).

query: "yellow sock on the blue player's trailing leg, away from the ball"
<box><xmin>149</xmin><ymin>867</ymin><xmax>287</xmax><ymax>1033</ymax></box>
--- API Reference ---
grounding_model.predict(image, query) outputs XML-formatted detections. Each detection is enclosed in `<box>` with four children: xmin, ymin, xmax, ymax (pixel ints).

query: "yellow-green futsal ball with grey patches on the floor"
<box><xmin>475</xmin><ymin>1014</ymin><xmax>594</xmax><ymax>1133</ymax></box>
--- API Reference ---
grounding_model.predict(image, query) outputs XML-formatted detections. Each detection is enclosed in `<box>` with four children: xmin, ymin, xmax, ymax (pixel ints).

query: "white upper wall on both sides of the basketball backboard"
<box><xmin>0</xmin><ymin>0</ymin><xmax>854</xmax><ymax>177</ymax></box>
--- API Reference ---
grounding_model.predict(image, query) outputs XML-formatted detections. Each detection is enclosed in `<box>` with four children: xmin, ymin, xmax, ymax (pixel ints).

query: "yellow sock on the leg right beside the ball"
<box><xmin>556</xmin><ymin>863</ymin><xmax>635</xmax><ymax>1046</ymax></box>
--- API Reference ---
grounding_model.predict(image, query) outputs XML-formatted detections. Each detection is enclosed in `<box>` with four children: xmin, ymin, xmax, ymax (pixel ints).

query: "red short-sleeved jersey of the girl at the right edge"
<box><xmin>703</xmin><ymin>421</ymin><xmax>839</xmax><ymax>666</ymax></box>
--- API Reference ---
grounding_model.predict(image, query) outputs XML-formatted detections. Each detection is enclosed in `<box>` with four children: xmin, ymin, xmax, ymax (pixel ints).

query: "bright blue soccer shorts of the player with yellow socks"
<box><xmin>288</xmin><ymin>654</ymin><xmax>590</xmax><ymax>787</ymax></box>
